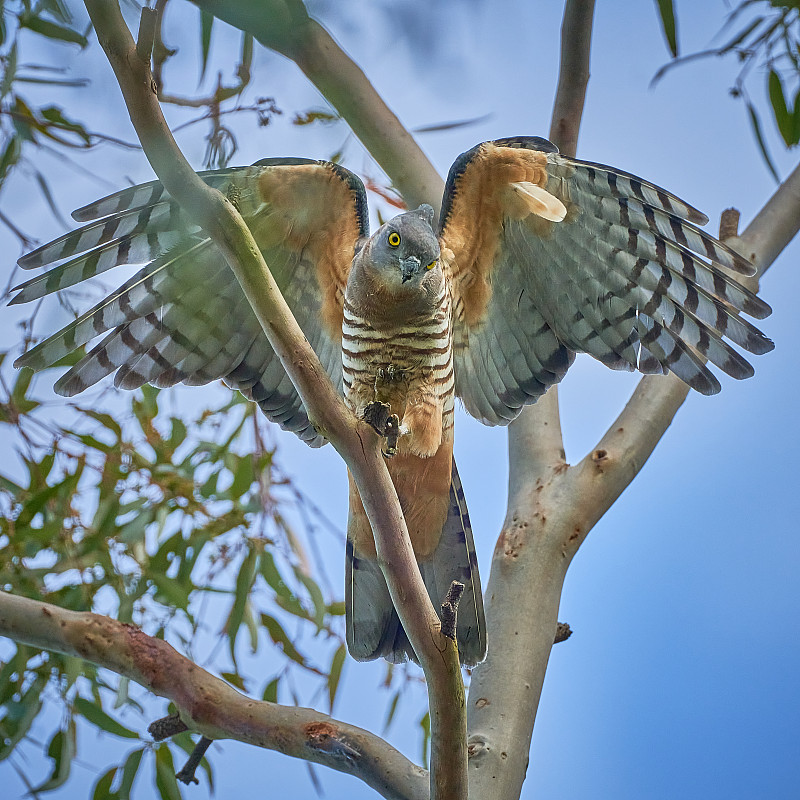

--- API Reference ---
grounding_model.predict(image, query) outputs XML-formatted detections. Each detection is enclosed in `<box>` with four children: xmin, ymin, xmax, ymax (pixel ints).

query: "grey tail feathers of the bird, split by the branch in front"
<box><xmin>345</xmin><ymin>461</ymin><xmax>486</xmax><ymax>666</ymax></box>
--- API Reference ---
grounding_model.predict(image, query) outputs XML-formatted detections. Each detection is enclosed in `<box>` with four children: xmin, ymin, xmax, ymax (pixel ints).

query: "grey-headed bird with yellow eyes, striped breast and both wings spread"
<box><xmin>13</xmin><ymin>137</ymin><xmax>773</xmax><ymax>665</ymax></box>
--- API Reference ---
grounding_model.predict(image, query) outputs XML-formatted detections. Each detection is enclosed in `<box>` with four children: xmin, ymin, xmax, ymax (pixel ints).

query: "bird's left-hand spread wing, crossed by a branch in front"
<box><xmin>12</xmin><ymin>159</ymin><xmax>368</xmax><ymax>446</ymax></box>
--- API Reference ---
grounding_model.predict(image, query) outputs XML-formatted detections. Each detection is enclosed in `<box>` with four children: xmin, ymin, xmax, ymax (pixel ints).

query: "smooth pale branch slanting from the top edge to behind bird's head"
<box><xmin>192</xmin><ymin>0</ymin><xmax>444</xmax><ymax>210</ymax></box>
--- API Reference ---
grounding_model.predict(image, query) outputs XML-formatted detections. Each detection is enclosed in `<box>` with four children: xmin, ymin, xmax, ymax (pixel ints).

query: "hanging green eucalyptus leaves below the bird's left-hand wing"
<box><xmin>0</xmin><ymin>360</ymin><xmax>345</xmax><ymax>798</ymax></box>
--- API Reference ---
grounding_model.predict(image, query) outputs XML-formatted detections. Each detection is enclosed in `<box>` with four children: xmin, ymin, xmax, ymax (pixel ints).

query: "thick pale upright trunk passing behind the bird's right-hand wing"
<box><xmin>467</xmin><ymin>0</ymin><xmax>594</xmax><ymax>800</ymax></box>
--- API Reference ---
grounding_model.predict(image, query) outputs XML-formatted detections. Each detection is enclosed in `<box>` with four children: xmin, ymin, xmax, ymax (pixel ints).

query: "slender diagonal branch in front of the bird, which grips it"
<box><xmin>80</xmin><ymin>0</ymin><xmax>466</xmax><ymax>798</ymax></box>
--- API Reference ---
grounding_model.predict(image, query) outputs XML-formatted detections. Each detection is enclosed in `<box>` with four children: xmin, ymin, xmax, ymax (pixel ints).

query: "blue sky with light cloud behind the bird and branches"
<box><xmin>0</xmin><ymin>0</ymin><xmax>800</xmax><ymax>800</ymax></box>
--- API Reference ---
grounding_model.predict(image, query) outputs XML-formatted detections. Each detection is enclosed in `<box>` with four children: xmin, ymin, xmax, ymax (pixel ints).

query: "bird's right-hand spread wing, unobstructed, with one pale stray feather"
<box><xmin>440</xmin><ymin>137</ymin><xmax>773</xmax><ymax>425</ymax></box>
